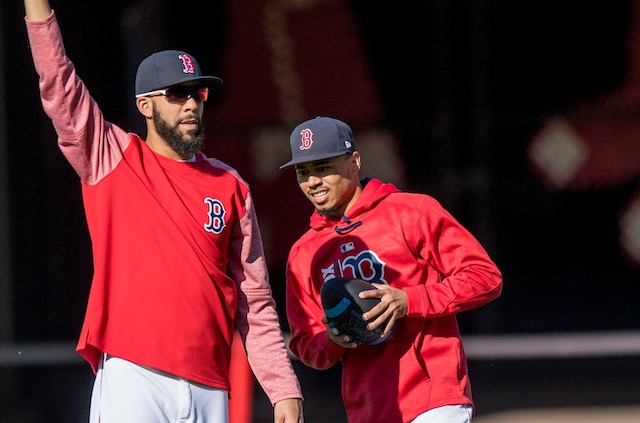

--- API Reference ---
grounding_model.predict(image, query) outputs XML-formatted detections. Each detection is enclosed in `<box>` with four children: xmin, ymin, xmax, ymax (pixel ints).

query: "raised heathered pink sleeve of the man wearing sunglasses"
<box><xmin>25</xmin><ymin>12</ymin><xmax>131</xmax><ymax>185</ymax></box>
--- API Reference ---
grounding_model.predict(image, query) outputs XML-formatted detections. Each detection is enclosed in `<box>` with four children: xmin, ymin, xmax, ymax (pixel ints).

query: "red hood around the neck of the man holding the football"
<box><xmin>309</xmin><ymin>178</ymin><xmax>400</xmax><ymax>234</ymax></box>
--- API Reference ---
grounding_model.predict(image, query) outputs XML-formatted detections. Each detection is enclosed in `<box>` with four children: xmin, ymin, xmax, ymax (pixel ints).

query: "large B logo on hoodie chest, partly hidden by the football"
<box><xmin>321</xmin><ymin>250</ymin><xmax>389</xmax><ymax>285</ymax></box>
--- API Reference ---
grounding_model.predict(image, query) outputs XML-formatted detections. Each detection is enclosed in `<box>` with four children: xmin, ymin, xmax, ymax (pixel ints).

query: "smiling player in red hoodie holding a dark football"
<box><xmin>281</xmin><ymin>117</ymin><xmax>502</xmax><ymax>423</ymax></box>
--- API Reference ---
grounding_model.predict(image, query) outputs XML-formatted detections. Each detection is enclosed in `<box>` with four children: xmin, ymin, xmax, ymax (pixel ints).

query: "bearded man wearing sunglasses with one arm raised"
<box><xmin>24</xmin><ymin>0</ymin><xmax>303</xmax><ymax>423</ymax></box>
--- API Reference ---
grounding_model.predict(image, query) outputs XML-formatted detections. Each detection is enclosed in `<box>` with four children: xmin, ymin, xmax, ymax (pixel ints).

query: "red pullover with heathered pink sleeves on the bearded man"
<box><xmin>27</xmin><ymin>13</ymin><xmax>302</xmax><ymax>403</ymax></box>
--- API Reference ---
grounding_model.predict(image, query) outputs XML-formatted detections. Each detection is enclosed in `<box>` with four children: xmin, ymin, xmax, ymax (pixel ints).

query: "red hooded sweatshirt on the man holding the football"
<box><xmin>287</xmin><ymin>179</ymin><xmax>502</xmax><ymax>423</ymax></box>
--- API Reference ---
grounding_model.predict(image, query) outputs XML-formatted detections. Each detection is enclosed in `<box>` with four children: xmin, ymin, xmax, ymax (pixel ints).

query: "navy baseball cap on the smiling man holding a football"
<box><xmin>280</xmin><ymin>116</ymin><xmax>356</xmax><ymax>169</ymax></box>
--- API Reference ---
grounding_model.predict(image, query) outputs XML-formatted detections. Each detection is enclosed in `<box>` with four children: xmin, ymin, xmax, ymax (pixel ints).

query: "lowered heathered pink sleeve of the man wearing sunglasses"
<box><xmin>229</xmin><ymin>193</ymin><xmax>302</xmax><ymax>404</ymax></box>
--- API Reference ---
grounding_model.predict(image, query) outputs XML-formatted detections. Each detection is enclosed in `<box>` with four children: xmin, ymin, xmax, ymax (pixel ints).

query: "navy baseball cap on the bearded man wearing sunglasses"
<box><xmin>135</xmin><ymin>50</ymin><xmax>222</xmax><ymax>95</ymax></box>
